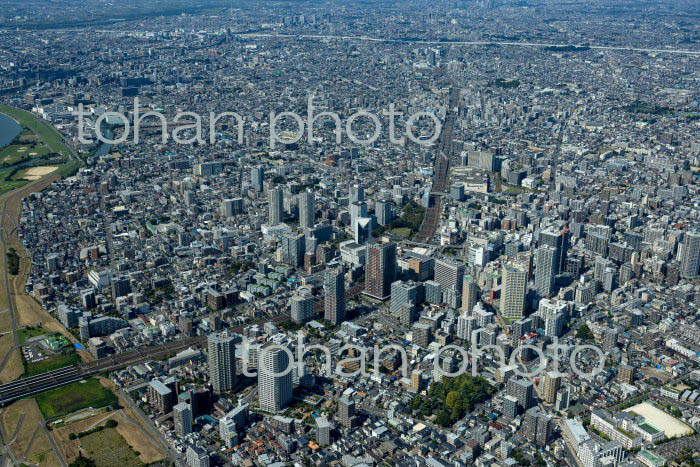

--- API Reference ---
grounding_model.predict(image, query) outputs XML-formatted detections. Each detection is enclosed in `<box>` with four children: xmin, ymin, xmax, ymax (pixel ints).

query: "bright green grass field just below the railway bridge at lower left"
<box><xmin>36</xmin><ymin>378</ymin><xmax>119</xmax><ymax>419</ymax></box>
